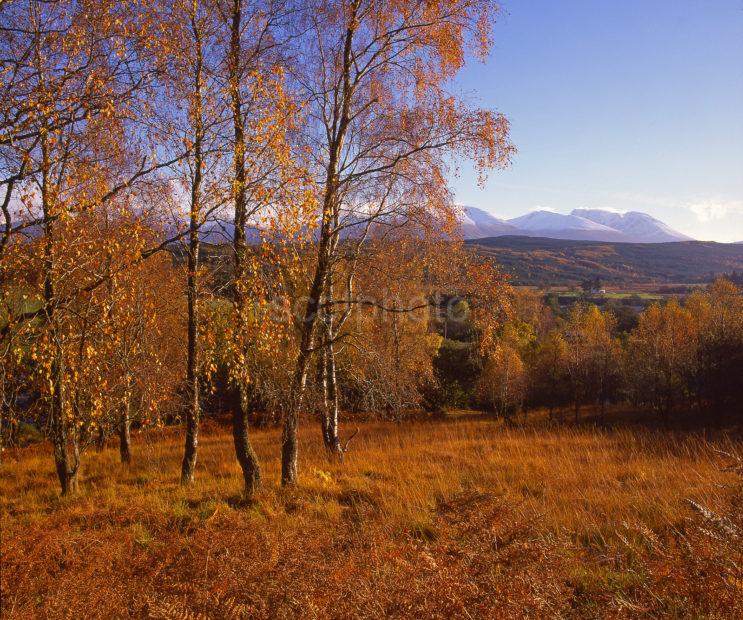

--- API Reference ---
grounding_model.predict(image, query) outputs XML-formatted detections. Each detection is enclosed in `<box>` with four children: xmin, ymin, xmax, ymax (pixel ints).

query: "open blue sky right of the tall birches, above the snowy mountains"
<box><xmin>452</xmin><ymin>0</ymin><xmax>743</xmax><ymax>242</ymax></box>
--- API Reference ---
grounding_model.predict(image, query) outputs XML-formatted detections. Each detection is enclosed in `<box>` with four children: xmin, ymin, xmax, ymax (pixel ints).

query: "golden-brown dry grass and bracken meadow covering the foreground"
<box><xmin>0</xmin><ymin>418</ymin><xmax>743</xmax><ymax>618</ymax></box>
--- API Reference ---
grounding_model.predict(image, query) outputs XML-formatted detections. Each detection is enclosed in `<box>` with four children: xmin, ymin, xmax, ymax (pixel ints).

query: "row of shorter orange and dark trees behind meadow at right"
<box><xmin>464</xmin><ymin>278</ymin><xmax>743</xmax><ymax>425</ymax></box>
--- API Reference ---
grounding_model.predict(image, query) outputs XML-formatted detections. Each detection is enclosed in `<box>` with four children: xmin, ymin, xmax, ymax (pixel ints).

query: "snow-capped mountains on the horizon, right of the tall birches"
<box><xmin>460</xmin><ymin>207</ymin><xmax>692</xmax><ymax>243</ymax></box>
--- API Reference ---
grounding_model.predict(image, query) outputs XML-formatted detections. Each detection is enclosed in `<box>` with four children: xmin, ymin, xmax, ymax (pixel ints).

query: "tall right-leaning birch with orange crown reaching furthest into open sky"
<box><xmin>282</xmin><ymin>0</ymin><xmax>512</xmax><ymax>484</ymax></box>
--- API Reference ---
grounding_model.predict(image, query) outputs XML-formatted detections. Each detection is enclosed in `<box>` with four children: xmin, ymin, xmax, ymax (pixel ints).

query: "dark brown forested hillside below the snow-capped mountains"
<box><xmin>467</xmin><ymin>236</ymin><xmax>743</xmax><ymax>286</ymax></box>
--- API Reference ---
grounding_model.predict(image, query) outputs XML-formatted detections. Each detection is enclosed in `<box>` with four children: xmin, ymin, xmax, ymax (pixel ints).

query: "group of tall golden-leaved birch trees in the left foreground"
<box><xmin>0</xmin><ymin>0</ymin><xmax>514</xmax><ymax>495</ymax></box>
